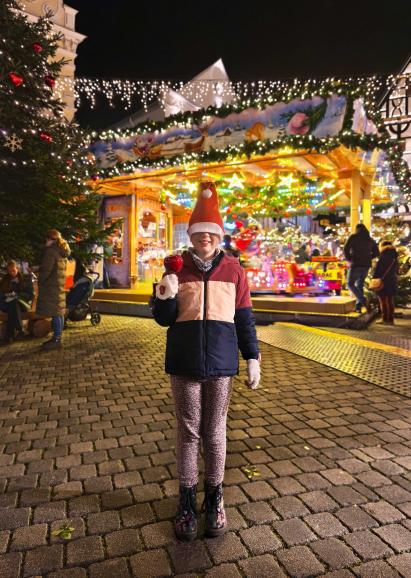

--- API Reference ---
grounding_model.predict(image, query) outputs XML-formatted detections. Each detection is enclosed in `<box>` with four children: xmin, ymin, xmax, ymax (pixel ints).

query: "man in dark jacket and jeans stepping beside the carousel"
<box><xmin>344</xmin><ymin>223</ymin><xmax>379</xmax><ymax>313</ymax></box>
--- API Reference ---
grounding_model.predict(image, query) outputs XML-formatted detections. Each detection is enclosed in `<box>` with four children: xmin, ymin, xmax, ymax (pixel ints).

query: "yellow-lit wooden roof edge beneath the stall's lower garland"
<box><xmin>93</xmin><ymin>145</ymin><xmax>391</xmax><ymax>212</ymax></box>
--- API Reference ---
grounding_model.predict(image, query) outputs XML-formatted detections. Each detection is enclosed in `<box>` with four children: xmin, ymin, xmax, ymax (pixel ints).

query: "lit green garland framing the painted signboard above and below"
<box><xmin>92</xmin><ymin>79</ymin><xmax>411</xmax><ymax>202</ymax></box>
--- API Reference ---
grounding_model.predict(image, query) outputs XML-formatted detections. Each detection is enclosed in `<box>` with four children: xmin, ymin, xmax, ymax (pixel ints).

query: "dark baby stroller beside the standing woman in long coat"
<box><xmin>66</xmin><ymin>271</ymin><xmax>101</xmax><ymax>325</ymax></box>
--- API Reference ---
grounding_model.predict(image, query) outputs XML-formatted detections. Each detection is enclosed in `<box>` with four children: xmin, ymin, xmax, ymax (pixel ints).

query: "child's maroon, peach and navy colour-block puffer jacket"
<box><xmin>153</xmin><ymin>252</ymin><xmax>259</xmax><ymax>378</ymax></box>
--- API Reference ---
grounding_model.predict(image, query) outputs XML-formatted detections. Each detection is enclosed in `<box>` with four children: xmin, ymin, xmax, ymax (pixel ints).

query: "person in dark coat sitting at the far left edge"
<box><xmin>0</xmin><ymin>261</ymin><xmax>34</xmax><ymax>344</ymax></box>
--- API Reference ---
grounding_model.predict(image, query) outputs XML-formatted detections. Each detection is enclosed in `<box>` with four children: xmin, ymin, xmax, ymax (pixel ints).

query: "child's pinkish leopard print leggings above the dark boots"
<box><xmin>170</xmin><ymin>375</ymin><xmax>232</xmax><ymax>487</ymax></box>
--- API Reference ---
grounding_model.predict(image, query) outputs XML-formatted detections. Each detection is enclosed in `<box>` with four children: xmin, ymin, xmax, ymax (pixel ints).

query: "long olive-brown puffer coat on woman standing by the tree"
<box><xmin>36</xmin><ymin>242</ymin><xmax>70</xmax><ymax>317</ymax></box>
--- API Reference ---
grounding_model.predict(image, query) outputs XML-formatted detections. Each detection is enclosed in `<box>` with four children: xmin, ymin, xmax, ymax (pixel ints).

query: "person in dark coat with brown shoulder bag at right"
<box><xmin>373</xmin><ymin>241</ymin><xmax>398</xmax><ymax>325</ymax></box>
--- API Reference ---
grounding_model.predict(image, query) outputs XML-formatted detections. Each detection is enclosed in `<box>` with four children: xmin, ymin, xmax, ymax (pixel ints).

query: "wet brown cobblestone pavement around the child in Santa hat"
<box><xmin>0</xmin><ymin>316</ymin><xmax>411</xmax><ymax>578</ymax></box>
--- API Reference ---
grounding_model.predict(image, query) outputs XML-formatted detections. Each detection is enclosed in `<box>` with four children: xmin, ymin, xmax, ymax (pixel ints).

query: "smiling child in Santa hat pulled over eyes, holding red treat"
<box><xmin>153</xmin><ymin>183</ymin><xmax>260</xmax><ymax>540</ymax></box>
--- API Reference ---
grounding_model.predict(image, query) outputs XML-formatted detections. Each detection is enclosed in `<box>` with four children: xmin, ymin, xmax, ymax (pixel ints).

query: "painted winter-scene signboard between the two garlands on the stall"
<box><xmin>89</xmin><ymin>95</ymin><xmax>347</xmax><ymax>168</ymax></box>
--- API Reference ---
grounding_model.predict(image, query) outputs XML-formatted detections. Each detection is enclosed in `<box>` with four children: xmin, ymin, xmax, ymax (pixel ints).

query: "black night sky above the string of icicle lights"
<box><xmin>66</xmin><ymin>0</ymin><xmax>411</xmax><ymax>127</ymax></box>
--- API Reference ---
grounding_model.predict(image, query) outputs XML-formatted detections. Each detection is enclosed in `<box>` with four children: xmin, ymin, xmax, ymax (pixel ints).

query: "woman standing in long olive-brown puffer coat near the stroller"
<box><xmin>36</xmin><ymin>229</ymin><xmax>70</xmax><ymax>350</ymax></box>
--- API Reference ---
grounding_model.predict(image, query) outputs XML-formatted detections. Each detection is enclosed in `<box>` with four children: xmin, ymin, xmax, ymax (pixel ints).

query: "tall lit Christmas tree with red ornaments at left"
<box><xmin>0</xmin><ymin>0</ymin><xmax>112</xmax><ymax>262</ymax></box>
